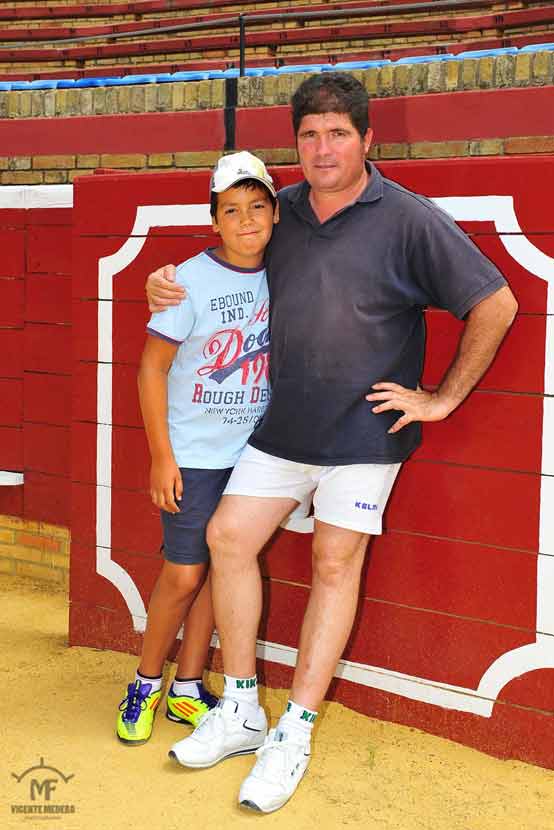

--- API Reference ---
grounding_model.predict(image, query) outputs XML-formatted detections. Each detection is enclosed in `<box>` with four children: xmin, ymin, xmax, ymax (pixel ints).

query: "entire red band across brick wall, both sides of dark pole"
<box><xmin>0</xmin><ymin>87</ymin><xmax>554</xmax><ymax>156</ymax></box>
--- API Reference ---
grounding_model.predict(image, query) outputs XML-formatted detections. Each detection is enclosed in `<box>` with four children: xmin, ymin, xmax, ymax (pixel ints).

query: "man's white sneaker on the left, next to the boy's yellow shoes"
<box><xmin>169</xmin><ymin>698</ymin><xmax>267</xmax><ymax>767</ymax></box>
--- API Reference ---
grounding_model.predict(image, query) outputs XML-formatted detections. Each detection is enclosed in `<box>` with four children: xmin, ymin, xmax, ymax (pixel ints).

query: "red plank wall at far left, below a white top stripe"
<box><xmin>0</xmin><ymin>208</ymin><xmax>72</xmax><ymax>526</ymax></box>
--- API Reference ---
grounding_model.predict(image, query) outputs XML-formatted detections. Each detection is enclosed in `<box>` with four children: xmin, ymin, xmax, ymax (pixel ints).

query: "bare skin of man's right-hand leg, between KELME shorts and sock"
<box><xmin>291</xmin><ymin>521</ymin><xmax>370</xmax><ymax>711</ymax></box>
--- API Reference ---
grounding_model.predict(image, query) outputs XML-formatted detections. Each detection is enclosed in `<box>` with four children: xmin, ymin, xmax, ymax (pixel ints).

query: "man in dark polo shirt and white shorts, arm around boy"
<box><xmin>147</xmin><ymin>73</ymin><xmax>517</xmax><ymax>812</ymax></box>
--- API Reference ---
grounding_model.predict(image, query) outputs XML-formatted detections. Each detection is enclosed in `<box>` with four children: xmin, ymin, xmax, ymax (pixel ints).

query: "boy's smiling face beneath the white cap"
<box><xmin>212</xmin><ymin>184</ymin><xmax>279</xmax><ymax>268</ymax></box>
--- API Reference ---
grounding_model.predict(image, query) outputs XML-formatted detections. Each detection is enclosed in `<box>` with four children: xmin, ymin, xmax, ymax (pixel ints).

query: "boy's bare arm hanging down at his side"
<box><xmin>138</xmin><ymin>335</ymin><xmax>183</xmax><ymax>513</ymax></box>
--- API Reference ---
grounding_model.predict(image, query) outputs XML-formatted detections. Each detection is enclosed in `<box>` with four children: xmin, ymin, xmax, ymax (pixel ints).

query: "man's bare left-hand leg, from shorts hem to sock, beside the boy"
<box><xmin>207</xmin><ymin>496</ymin><xmax>297</xmax><ymax>677</ymax></box>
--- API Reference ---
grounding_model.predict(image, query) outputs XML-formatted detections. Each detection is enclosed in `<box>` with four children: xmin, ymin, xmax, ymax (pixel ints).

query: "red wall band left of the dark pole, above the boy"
<box><xmin>0</xmin><ymin>110</ymin><xmax>225</xmax><ymax>156</ymax></box>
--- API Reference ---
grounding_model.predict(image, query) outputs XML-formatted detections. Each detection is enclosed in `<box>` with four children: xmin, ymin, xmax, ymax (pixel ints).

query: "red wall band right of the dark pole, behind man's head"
<box><xmin>236</xmin><ymin>87</ymin><xmax>554</xmax><ymax>149</ymax></box>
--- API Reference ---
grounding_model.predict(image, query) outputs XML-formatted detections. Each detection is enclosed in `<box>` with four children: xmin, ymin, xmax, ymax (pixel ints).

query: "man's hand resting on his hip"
<box><xmin>366</xmin><ymin>381</ymin><xmax>454</xmax><ymax>433</ymax></box>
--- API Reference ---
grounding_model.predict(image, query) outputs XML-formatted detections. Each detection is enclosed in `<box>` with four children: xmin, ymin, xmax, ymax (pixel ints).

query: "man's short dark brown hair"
<box><xmin>291</xmin><ymin>72</ymin><xmax>369</xmax><ymax>138</ymax></box>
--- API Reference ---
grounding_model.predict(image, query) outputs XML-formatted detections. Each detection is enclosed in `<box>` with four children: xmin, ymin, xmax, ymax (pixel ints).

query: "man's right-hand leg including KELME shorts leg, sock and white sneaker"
<box><xmin>239</xmin><ymin>464</ymin><xmax>399</xmax><ymax>813</ymax></box>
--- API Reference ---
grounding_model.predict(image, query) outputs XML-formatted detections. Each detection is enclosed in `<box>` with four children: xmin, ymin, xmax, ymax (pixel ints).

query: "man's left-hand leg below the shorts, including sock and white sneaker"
<box><xmin>169</xmin><ymin>495</ymin><xmax>297</xmax><ymax>767</ymax></box>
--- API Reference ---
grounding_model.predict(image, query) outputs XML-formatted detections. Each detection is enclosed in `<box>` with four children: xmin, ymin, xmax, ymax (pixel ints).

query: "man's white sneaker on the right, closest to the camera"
<box><xmin>239</xmin><ymin>729</ymin><xmax>310</xmax><ymax>813</ymax></box>
